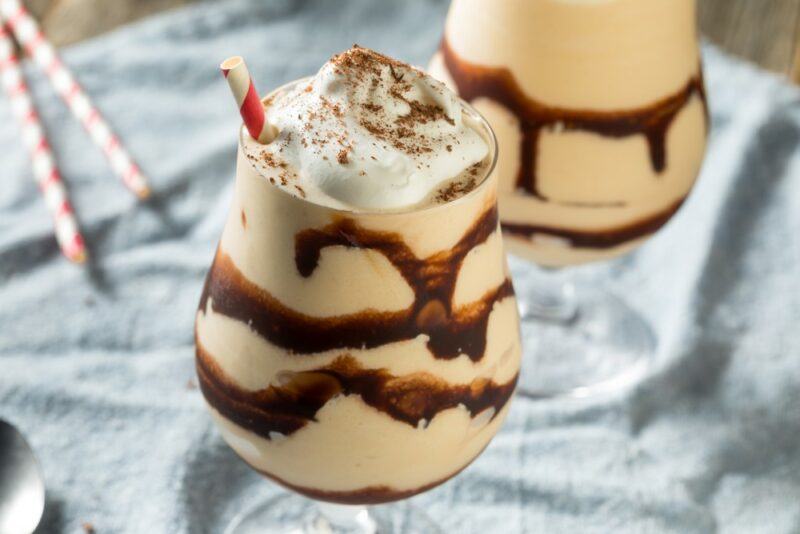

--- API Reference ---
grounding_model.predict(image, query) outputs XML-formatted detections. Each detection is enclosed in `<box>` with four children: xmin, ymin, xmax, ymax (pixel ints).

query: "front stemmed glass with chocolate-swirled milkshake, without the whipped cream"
<box><xmin>195</xmin><ymin>80</ymin><xmax>521</xmax><ymax>533</ymax></box>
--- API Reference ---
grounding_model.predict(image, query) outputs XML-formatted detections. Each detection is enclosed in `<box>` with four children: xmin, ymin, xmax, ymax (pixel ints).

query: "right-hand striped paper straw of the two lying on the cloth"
<box><xmin>0</xmin><ymin>0</ymin><xmax>150</xmax><ymax>198</ymax></box>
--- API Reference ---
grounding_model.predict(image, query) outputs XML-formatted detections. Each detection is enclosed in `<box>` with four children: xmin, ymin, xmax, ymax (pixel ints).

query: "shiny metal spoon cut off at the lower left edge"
<box><xmin>0</xmin><ymin>419</ymin><xmax>44</xmax><ymax>534</ymax></box>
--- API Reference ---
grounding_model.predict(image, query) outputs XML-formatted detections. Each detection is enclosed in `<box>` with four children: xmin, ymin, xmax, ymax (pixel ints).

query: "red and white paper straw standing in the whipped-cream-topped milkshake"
<box><xmin>219</xmin><ymin>56</ymin><xmax>278</xmax><ymax>144</ymax></box>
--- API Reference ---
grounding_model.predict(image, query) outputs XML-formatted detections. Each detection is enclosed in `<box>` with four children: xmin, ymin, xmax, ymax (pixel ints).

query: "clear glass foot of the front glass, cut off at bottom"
<box><xmin>225</xmin><ymin>493</ymin><xmax>441</xmax><ymax>534</ymax></box>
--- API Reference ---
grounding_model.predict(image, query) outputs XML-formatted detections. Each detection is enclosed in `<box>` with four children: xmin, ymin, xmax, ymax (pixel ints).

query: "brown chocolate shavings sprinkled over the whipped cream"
<box><xmin>247</xmin><ymin>45</ymin><xmax>488</xmax><ymax>207</ymax></box>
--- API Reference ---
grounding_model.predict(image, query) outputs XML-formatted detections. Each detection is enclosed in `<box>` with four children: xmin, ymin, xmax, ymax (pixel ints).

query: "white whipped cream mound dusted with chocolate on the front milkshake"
<box><xmin>244</xmin><ymin>46</ymin><xmax>489</xmax><ymax>210</ymax></box>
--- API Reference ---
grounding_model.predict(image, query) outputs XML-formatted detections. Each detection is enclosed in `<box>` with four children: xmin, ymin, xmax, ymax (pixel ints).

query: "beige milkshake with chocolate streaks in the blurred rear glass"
<box><xmin>430</xmin><ymin>0</ymin><xmax>706</xmax><ymax>266</ymax></box>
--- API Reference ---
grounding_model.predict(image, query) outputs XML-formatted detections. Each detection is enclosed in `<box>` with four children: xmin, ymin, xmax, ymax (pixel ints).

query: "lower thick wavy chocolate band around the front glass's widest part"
<box><xmin>196</xmin><ymin>343</ymin><xmax>517</xmax><ymax>439</ymax></box>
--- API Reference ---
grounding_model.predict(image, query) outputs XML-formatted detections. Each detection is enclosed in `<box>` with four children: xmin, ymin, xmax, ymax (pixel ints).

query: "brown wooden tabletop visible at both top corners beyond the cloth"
<box><xmin>28</xmin><ymin>0</ymin><xmax>800</xmax><ymax>84</ymax></box>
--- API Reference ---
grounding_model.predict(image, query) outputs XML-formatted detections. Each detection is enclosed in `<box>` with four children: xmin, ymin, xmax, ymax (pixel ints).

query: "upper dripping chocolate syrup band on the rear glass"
<box><xmin>441</xmin><ymin>38</ymin><xmax>708</xmax><ymax>201</ymax></box>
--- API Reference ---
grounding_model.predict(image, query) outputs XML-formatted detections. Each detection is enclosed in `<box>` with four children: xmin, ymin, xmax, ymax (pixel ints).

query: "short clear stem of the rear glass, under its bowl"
<box><xmin>518</xmin><ymin>267</ymin><xmax>578</xmax><ymax>324</ymax></box>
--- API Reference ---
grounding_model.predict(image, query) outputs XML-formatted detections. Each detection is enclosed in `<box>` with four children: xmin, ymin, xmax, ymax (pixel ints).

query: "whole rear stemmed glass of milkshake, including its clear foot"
<box><xmin>429</xmin><ymin>0</ymin><xmax>707</xmax><ymax>397</ymax></box>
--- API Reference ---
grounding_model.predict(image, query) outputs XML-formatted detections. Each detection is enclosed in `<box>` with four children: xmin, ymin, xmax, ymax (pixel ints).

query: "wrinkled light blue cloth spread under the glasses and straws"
<box><xmin>0</xmin><ymin>0</ymin><xmax>800</xmax><ymax>534</ymax></box>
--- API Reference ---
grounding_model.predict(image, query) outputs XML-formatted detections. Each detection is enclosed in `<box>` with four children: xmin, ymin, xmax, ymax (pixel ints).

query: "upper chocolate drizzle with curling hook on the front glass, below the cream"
<box><xmin>200</xmin><ymin>206</ymin><xmax>514</xmax><ymax>361</ymax></box>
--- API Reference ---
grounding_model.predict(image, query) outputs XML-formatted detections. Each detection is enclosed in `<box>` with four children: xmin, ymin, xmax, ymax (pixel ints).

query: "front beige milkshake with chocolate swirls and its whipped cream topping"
<box><xmin>196</xmin><ymin>47</ymin><xmax>520</xmax><ymax>503</ymax></box>
